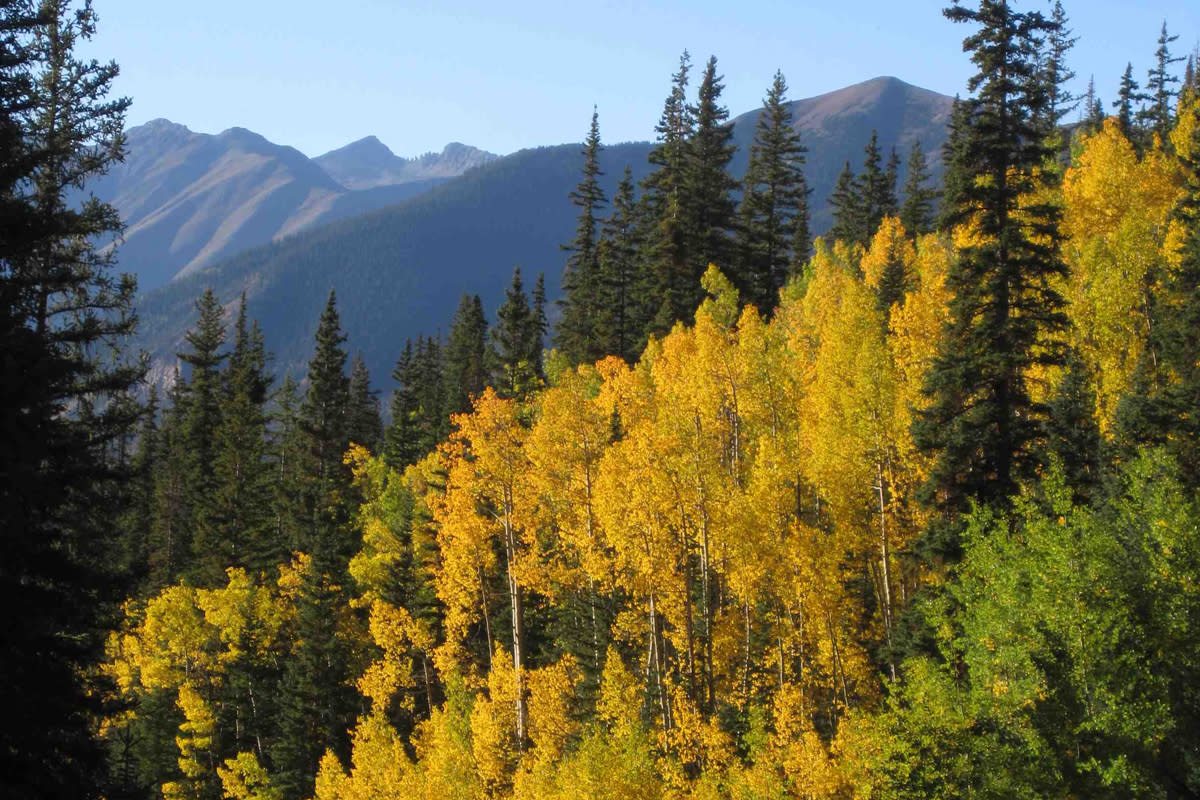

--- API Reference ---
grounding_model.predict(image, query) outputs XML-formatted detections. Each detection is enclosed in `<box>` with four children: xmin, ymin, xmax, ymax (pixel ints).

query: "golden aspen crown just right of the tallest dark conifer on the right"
<box><xmin>1063</xmin><ymin>119</ymin><xmax>1178</xmax><ymax>432</ymax></box>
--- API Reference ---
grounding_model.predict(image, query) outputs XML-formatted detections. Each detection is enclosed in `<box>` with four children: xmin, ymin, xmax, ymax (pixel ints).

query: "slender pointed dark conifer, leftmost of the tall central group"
<box><xmin>556</xmin><ymin>109</ymin><xmax>605</xmax><ymax>363</ymax></box>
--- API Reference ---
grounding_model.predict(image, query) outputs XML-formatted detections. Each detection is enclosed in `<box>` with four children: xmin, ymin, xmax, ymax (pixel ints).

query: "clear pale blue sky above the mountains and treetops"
<box><xmin>88</xmin><ymin>0</ymin><xmax>1200</xmax><ymax>156</ymax></box>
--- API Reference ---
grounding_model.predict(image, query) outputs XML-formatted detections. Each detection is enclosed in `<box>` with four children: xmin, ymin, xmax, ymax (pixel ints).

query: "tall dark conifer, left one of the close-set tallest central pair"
<box><xmin>638</xmin><ymin>50</ymin><xmax>696</xmax><ymax>333</ymax></box>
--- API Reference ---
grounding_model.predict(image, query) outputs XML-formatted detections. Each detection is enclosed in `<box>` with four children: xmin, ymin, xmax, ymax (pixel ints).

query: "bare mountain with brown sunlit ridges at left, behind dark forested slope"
<box><xmin>86</xmin><ymin>119</ymin><xmax>487</xmax><ymax>291</ymax></box>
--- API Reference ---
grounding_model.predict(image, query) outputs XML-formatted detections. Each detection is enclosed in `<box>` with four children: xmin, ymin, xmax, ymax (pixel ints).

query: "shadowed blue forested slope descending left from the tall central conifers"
<box><xmin>139</xmin><ymin>144</ymin><xmax>649</xmax><ymax>383</ymax></box>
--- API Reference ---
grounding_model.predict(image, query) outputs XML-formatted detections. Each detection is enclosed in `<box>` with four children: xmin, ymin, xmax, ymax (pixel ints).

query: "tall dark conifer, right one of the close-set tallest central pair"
<box><xmin>683</xmin><ymin>56</ymin><xmax>738</xmax><ymax>284</ymax></box>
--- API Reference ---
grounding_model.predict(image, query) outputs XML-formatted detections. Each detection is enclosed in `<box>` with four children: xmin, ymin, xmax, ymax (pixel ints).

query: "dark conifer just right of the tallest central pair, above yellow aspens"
<box><xmin>734</xmin><ymin>72</ymin><xmax>811</xmax><ymax>313</ymax></box>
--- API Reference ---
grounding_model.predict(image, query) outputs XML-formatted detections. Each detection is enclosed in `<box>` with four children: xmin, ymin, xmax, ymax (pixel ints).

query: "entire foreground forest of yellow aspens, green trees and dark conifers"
<box><xmin>0</xmin><ymin>0</ymin><xmax>1200</xmax><ymax>800</ymax></box>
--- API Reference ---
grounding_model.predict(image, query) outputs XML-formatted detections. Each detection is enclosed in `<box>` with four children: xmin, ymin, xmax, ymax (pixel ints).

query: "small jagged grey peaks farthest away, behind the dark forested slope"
<box><xmin>313</xmin><ymin>136</ymin><xmax>499</xmax><ymax>190</ymax></box>
